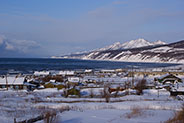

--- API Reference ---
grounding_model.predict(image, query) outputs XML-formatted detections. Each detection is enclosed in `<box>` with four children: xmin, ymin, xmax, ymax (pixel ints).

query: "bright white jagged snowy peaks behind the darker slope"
<box><xmin>98</xmin><ymin>38</ymin><xmax>166</xmax><ymax>51</ymax></box>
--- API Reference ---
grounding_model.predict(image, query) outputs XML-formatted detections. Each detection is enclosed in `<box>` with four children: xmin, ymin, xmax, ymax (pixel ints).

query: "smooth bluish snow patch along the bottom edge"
<box><xmin>58</xmin><ymin>109</ymin><xmax>173</xmax><ymax>123</ymax></box>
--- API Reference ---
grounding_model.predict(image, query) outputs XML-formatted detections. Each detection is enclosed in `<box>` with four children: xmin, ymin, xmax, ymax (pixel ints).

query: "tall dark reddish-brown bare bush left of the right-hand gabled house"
<box><xmin>135</xmin><ymin>79</ymin><xmax>146</xmax><ymax>95</ymax></box>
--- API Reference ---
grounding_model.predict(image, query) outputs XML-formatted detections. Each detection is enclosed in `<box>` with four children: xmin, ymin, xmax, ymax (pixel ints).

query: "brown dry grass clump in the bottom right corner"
<box><xmin>165</xmin><ymin>104</ymin><xmax>184</xmax><ymax>123</ymax></box>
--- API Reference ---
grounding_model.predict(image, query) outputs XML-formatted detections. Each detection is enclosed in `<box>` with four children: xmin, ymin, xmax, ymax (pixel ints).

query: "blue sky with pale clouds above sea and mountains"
<box><xmin>0</xmin><ymin>0</ymin><xmax>184</xmax><ymax>57</ymax></box>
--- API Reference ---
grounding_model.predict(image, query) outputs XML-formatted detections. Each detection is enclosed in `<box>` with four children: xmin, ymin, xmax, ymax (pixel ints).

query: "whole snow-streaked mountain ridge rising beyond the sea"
<box><xmin>53</xmin><ymin>39</ymin><xmax>184</xmax><ymax>63</ymax></box>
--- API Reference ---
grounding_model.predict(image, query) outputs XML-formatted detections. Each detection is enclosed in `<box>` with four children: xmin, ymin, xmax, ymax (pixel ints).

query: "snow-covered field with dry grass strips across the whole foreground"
<box><xmin>0</xmin><ymin>89</ymin><xmax>183</xmax><ymax>123</ymax></box>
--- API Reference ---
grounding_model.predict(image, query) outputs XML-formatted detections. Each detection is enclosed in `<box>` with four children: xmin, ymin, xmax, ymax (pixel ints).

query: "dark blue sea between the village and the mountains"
<box><xmin>0</xmin><ymin>58</ymin><xmax>177</xmax><ymax>74</ymax></box>
